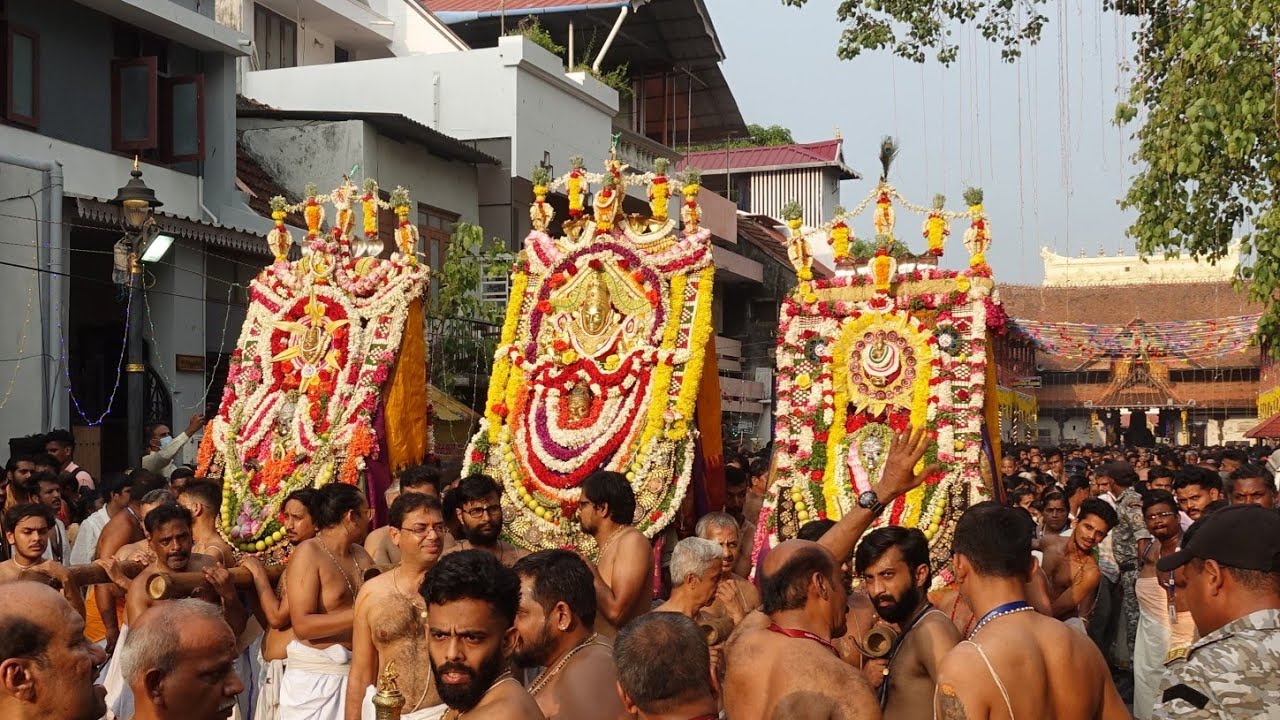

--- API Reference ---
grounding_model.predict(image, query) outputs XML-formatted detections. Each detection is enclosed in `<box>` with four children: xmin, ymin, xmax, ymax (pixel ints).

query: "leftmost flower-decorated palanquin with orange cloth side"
<box><xmin>197</xmin><ymin>181</ymin><xmax>430</xmax><ymax>553</ymax></box>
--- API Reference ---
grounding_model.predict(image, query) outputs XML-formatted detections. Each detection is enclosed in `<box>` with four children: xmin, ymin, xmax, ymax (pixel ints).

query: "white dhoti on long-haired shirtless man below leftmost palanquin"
<box><xmin>279</xmin><ymin>641</ymin><xmax>351</xmax><ymax>720</ymax></box>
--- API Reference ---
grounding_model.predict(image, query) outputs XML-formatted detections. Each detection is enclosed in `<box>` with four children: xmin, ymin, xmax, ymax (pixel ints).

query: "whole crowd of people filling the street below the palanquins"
<box><xmin>0</xmin><ymin>420</ymin><xmax>1280</xmax><ymax>720</ymax></box>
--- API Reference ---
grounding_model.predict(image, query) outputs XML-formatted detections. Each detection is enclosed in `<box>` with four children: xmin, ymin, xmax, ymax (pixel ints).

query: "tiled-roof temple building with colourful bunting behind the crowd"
<box><xmin>1000</xmin><ymin>243</ymin><xmax>1262</xmax><ymax>446</ymax></box>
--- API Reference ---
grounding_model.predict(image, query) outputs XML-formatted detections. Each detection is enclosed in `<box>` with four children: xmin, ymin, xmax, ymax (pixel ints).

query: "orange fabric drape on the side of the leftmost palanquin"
<box><xmin>384</xmin><ymin>299</ymin><xmax>430</xmax><ymax>474</ymax></box>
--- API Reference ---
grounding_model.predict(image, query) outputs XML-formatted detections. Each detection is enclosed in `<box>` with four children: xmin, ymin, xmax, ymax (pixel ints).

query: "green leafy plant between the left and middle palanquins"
<box><xmin>428</xmin><ymin>223</ymin><xmax>509</xmax><ymax>388</ymax></box>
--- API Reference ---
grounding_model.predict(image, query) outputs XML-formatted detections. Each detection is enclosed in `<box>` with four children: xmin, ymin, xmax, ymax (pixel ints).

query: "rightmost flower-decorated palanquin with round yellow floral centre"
<box><xmin>754</xmin><ymin>154</ymin><xmax>1004</xmax><ymax>583</ymax></box>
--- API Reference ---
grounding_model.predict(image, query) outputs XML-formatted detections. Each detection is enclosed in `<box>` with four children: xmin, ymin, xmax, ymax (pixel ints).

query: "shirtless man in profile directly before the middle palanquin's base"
<box><xmin>577</xmin><ymin>470</ymin><xmax>653</xmax><ymax>638</ymax></box>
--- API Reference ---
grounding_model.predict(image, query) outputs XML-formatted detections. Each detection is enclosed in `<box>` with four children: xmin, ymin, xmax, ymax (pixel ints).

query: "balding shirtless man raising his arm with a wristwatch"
<box><xmin>723</xmin><ymin>429</ymin><xmax>937</xmax><ymax>720</ymax></box>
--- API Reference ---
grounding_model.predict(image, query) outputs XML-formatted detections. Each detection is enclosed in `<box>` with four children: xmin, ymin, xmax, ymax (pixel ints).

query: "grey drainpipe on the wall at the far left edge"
<box><xmin>0</xmin><ymin>152</ymin><xmax>70</xmax><ymax>432</ymax></box>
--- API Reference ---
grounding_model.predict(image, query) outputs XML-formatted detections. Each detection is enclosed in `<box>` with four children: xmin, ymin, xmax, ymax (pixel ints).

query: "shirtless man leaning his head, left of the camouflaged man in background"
<box><xmin>1041</xmin><ymin>497</ymin><xmax>1119</xmax><ymax>633</ymax></box>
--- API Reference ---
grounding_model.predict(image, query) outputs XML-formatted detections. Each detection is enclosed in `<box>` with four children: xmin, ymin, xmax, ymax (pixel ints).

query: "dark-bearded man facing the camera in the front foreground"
<box><xmin>422</xmin><ymin>550</ymin><xmax>545</xmax><ymax>720</ymax></box>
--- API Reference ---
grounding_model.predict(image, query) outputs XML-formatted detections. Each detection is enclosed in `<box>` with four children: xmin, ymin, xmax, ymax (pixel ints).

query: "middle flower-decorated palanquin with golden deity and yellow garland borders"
<box><xmin>466</xmin><ymin>151</ymin><xmax>719</xmax><ymax>550</ymax></box>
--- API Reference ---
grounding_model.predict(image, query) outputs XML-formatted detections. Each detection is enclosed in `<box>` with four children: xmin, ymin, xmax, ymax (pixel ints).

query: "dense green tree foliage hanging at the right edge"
<box><xmin>1116</xmin><ymin>0</ymin><xmax>1280</xmax><ymax>346</ymax></box>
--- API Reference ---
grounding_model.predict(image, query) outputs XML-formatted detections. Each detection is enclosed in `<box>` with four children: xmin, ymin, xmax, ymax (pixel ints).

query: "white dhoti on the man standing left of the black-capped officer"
<box><xmin>1133</xmin><ymin>578</ymin><xmax>1196</xmax><ymax>720</ymax></box>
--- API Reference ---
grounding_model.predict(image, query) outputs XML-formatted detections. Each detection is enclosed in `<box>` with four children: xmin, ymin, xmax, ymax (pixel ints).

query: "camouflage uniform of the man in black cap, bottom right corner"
<box><xmin>1152</xmin><ymin>610</ymin><xmax>1280</xmax><ymax>720</ymax></box>
